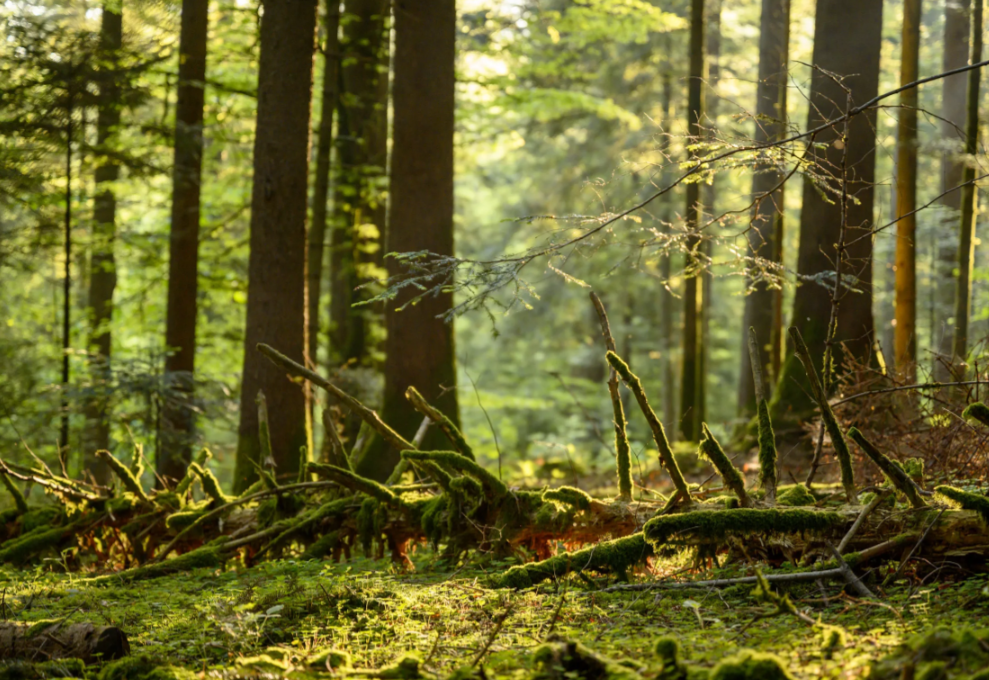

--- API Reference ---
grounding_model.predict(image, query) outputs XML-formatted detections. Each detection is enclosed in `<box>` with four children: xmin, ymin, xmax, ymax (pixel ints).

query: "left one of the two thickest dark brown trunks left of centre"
<box><xmin>234</xmin><ymin>0</ymin><xmax>316</xmax><ymax>491</ymax></box>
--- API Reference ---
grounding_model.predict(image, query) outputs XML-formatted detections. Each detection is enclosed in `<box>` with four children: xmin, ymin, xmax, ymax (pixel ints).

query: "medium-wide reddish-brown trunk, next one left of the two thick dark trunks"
<box><xmin>161</xmin><ymin>0</ymin><xmax>209</xmax><ymax>479</ymax></box>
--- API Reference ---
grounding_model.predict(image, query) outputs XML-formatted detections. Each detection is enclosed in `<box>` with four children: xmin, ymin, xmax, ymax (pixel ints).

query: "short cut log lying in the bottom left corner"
<box><xmin>0</xmin><ymin>621</ymin><xmax>130</xmax><ymax>664</ymax></box>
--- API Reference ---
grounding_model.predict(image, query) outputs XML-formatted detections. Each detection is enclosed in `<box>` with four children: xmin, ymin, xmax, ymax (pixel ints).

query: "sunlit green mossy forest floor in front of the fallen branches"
<box><xmin>0</xmin><ymin>549</ymin><xmax>989</xmax><ymax>679</ymax></box>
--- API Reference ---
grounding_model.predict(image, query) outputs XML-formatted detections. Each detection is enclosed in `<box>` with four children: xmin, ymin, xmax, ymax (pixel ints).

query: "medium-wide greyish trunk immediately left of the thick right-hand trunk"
<box><xmin>738</xmin><ymin>0</ymin><xmax>790</xmax><ymax>417</ymax></box>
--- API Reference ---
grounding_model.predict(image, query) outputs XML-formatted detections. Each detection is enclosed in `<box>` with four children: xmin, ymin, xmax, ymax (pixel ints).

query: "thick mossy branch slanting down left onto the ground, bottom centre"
<box><xmin>494</xmin><ymin>533</ymin><xmax>653</xmax><ymax>589</ymax></box>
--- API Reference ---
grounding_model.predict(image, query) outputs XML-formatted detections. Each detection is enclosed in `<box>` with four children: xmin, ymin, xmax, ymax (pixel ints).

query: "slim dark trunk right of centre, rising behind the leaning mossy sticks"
<box><xmin>680</xmin><ymin>0</ymin><xmax>706</xmax><ymax>441</ymax></box>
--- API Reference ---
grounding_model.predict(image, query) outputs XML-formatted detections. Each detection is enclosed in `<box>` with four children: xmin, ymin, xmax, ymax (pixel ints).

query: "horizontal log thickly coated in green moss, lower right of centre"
<box><xmin>643</xmin><ymin>508</ymin><xmax>844</xmax><ymax>546</ymax></box>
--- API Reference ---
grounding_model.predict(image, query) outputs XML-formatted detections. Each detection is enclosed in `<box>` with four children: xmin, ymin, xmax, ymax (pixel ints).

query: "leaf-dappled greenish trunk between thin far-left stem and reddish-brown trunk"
<box><xmin>83</xmin><ymin>4</ymin><xmax>123</xmax><ymax>482</ymax></box>
